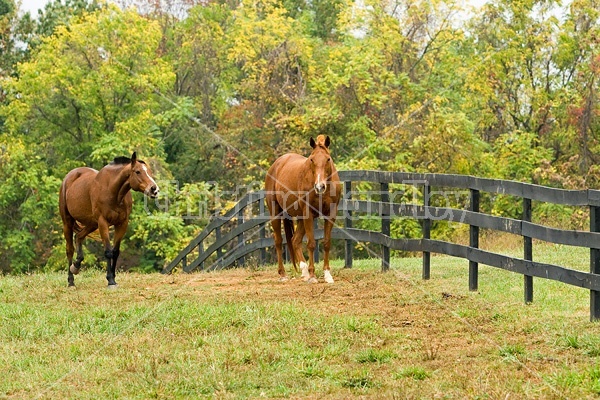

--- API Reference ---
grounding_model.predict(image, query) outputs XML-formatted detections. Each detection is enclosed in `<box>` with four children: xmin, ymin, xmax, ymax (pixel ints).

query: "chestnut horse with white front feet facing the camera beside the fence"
<box><xmin>265</xmin><ymin>135</ymin><xmax>342</xmax><ymax>283</ymax></box>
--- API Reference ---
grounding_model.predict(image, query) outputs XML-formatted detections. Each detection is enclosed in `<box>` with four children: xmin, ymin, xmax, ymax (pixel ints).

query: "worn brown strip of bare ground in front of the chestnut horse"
<box><xmin>156</xmin><ymin>269</ymin><xmax>502</xmax><ymax>354</ymax></box>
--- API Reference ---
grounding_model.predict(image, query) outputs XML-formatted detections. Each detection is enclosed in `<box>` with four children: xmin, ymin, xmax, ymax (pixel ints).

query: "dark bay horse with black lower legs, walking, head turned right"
<box><xmin>58</xmin><ymin>153</ymin><xmax>159</xmax><ymax>288</ymax></box>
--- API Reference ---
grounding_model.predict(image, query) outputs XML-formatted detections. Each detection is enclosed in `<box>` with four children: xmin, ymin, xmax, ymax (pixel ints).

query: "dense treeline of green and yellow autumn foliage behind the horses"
<box><xmin>0</xmin><ymin>0</ymin><xmax>600</xmax><ymax>272</ymax></box>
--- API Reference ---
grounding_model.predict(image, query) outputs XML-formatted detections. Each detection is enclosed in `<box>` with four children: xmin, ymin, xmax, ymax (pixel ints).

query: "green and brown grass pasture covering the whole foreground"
<box><xmin>0</xmin><ymin>239</ymin><xmax>600</xmax><ymax>399</ymax></box>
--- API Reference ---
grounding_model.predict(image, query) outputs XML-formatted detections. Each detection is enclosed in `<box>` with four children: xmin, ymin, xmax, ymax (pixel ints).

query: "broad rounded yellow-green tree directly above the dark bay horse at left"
<box><xmin>3</xmin><ymin>7</ymin><xmax>174</xmax><ymax>175</ymax></box>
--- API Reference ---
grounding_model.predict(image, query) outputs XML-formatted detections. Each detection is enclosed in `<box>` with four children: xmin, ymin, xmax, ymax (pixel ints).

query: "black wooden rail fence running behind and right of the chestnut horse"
<box><xmin>163</xmin><ymin>171</ymin><xmax>600</xmax><ymax>320</ymax></box>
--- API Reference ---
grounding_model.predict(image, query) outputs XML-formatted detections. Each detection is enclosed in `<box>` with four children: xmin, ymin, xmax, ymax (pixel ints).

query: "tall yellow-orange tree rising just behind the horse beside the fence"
<box><xmin>189</xmin><ymin>0</ymin><xmax>322</xmax><ymax>186</ymax></box>
